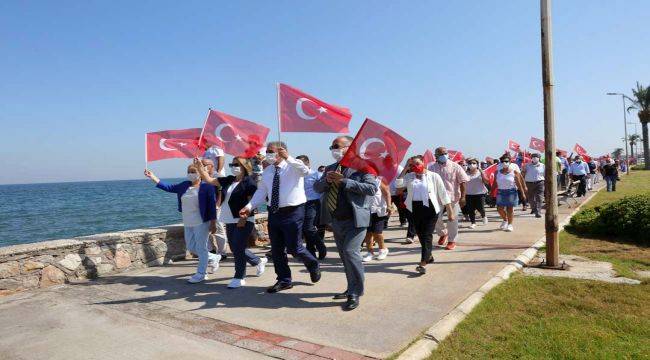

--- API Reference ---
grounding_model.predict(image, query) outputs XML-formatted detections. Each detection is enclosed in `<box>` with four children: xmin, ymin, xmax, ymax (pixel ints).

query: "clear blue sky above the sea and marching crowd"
<box><xmin>0</xmin><ymin>0</ymin><xmax>650</xmax><ymax>183</ymax></box>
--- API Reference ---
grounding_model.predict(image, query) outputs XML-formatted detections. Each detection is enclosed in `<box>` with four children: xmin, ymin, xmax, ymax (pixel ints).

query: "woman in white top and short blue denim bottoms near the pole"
<box><xmin>496</xmin><ymin>154</ymin><xmax>527</xmax><ymax>231</ymax></box>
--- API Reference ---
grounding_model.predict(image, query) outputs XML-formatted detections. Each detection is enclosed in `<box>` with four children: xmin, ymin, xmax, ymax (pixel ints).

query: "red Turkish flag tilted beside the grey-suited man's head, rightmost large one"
<box><xmin>341</xmin><ymin>119</ymin><xmax>411</xmax><ymax>184</ymax></box>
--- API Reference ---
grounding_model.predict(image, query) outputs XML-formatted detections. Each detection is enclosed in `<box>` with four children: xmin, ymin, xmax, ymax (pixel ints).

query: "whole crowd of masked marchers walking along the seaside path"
<box><xmin>144</xmin><ymin>136</ymin><xmax>619</xmax><ymax>310</ymax></box>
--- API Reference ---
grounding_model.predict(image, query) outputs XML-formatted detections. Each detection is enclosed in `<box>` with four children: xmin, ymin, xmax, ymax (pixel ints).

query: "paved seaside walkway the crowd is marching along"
<box><xmin>0</xmin><ymin>190</ymin><xmax>596</xmax><ymax>359</ymax></box>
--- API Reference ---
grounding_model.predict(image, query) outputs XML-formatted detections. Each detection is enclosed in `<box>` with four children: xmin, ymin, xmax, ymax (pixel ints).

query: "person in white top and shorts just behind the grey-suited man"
<box><xmin>361</xmin><ymin>176</ymin><xmax>393</xmax><ymax>262</ymax></box>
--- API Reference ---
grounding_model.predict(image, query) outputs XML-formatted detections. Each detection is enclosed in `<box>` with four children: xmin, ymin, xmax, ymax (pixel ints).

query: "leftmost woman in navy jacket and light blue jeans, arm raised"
<box><xmin>144</xmin><ymin>162</ymin><xmax>216</xmax><ymax>284</ymax></box>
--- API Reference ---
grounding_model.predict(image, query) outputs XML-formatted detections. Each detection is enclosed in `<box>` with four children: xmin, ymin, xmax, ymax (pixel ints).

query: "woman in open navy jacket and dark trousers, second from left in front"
<box><xmin>194</xmin><ymin>157</ymin><xmax>268</xmax><ymax>289</ymax></box>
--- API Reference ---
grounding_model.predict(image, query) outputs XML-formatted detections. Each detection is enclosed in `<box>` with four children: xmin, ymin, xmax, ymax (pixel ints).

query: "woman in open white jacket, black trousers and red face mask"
<box><xmin>396</xmin><ymin>155</ymin><xmax>455</xmax><ymax>274</ymax></box>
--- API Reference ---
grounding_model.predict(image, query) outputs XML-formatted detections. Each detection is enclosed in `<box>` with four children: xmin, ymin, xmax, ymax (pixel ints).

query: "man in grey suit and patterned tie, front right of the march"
<box><xmin>314</xmin><ymin>136</ymin><xmax>377</xmax><ymax>311</ymax></box>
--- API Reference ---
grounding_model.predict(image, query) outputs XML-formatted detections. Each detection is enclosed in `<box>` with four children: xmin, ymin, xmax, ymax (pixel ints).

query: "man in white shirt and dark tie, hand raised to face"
<box><xmin>239</xmin><ymin>141</ymin><xmax>321</xmax><ymax>293</ymax></box>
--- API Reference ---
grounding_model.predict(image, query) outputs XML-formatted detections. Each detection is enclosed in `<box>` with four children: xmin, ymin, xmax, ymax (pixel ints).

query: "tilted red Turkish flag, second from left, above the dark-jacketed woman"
<box><xmin>203</xmin><ymin>110</ymin><xmax>269</xmax><ymax>158</ymax></box>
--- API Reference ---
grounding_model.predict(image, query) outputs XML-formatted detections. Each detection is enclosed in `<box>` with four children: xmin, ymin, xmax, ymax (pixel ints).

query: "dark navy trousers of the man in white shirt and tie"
<box><xmin>268</xmin><ymin>204</ymin><xmax>318</xmax><ymax>284</ymax></box>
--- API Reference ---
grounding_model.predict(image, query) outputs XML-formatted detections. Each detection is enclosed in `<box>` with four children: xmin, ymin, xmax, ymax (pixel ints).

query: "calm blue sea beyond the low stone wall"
<box><xmin>0</xmin><ymin>179</ymin><xmax>187</xmax><ymax>246</ymax></box>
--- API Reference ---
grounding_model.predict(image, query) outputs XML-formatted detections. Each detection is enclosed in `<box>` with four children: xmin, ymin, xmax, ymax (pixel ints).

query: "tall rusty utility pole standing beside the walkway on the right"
<box><xmin>540</xmin><ymin>0</ymin><xmax>560</xmax><ymax>267</ymax></box>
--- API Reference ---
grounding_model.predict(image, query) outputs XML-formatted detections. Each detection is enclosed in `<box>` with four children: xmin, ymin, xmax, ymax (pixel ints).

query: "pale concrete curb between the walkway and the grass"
<box><xmin>397</xmin><ymin>186</ymin><xmax>603</xmax><ymax>360</ymax></box>
